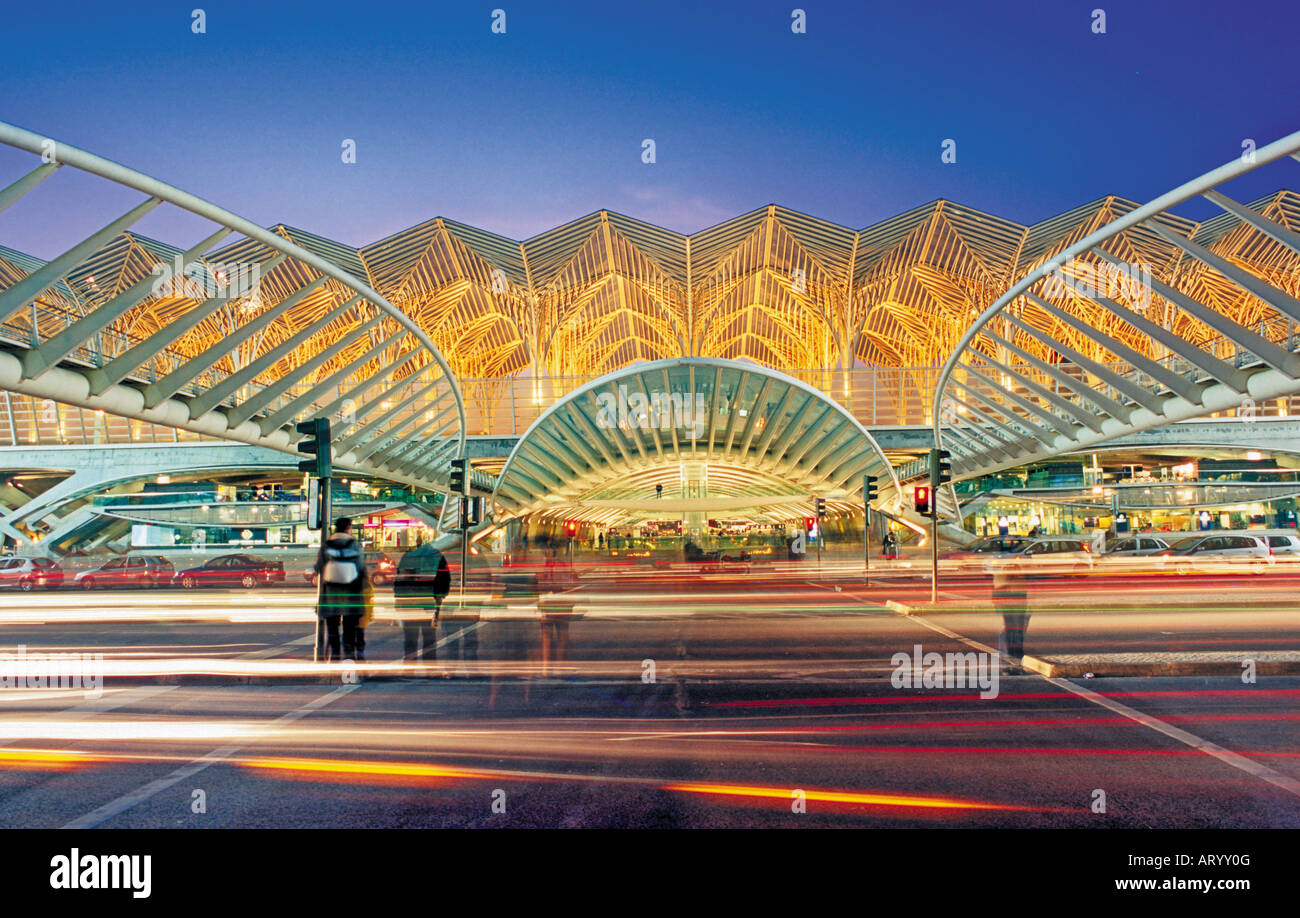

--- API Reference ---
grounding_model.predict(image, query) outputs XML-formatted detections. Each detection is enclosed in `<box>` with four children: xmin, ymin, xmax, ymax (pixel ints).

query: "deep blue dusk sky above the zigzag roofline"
<box><xmin>0</xmin><ymin>0</ymin><xmax>1300</xmax><ymax>256</ymax></box>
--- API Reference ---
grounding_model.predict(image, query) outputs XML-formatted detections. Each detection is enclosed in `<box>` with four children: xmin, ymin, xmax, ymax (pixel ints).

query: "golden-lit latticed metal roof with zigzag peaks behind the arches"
<box><xmin>10</xmin><ymin>191</ymin><xmax>1300</xmax><ymax>397</ymax></box>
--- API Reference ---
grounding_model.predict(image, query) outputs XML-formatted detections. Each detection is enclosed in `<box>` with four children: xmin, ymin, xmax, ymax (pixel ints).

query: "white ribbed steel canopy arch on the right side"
<box><xmin>933</xmin><ymin>131</ymin><xmax>1300</xmax><ymax>514</ymax></box>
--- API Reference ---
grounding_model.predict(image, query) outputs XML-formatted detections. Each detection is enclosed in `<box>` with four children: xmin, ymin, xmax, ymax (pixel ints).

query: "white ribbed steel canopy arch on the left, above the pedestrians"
<box><xmin>0</xmin><ymin>122</ymin><xmax>465</xmax><ymax>489</ymax></box>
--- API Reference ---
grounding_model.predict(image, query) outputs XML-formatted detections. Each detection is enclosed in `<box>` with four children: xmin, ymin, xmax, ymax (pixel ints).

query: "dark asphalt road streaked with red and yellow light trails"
<box><xmin>0</xmin><ymin>571</ymin><xmax>1300</xmax><ymax>827</ymax></box>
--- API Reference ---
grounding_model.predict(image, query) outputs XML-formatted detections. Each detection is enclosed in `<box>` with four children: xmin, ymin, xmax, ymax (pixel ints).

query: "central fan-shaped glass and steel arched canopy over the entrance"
<box><xmin>493</xmin><ymin>358</ymin><xmax>901</xmax><ymax>519</ymax></box>
